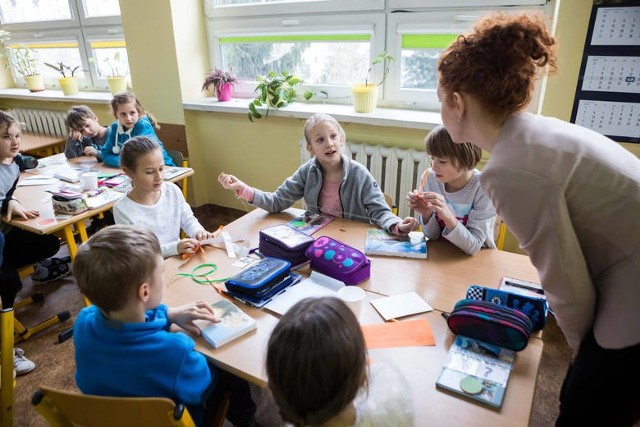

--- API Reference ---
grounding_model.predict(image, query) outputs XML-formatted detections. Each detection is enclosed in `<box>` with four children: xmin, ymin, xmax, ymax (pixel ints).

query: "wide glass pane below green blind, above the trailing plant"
<box><xmin>220</xmin><ymin>41</ymin><xmax>370</xmax><ymax>85</ymax></box>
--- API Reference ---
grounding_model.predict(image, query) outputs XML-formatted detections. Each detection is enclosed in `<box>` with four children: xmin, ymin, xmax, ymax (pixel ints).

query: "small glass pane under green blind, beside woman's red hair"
<box><xmin>400</xmin><ymin>49</ymin><xmax>442</xmax><ymax>90</ymax></box>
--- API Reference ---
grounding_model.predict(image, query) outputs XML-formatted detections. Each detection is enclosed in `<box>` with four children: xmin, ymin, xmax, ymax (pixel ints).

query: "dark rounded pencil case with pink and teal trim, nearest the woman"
<box><xmin>447</xmin><ymin>299</ymin><xmax>533</xmax><ymax>351</ymax></box>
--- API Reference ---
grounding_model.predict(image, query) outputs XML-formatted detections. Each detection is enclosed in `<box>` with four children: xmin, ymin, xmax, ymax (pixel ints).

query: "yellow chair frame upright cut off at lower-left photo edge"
<box><xmin>0</xmin><ymin>308</ymin><xmax>15</xmax><ymax>427</ymax></box>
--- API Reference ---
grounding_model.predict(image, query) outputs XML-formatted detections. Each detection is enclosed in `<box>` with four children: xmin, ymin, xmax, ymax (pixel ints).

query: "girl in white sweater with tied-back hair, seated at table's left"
<box><xmin>113</xmin><ymin>136</ymin><xmax>213</xmax><ymax>258</ymax></box>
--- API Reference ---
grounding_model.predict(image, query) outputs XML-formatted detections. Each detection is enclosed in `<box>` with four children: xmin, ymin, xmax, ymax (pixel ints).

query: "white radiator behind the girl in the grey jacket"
<box><xmin>300</xmin><ymin>138</ymin><xmax>429</xmax><ymax>218</ymax></box>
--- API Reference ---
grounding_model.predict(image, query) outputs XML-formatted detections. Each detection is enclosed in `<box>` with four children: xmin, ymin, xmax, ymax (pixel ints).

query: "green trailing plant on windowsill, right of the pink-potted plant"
<box><xmin>248</xmin><ymin>71</ymin><xmax>327</xmax><ymax>122</ymax></box>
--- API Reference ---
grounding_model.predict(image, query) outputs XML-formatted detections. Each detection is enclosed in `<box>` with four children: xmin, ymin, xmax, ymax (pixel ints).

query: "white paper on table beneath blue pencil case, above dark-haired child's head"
<box><xmin>264</xmin><ymin>271</ymin><xmax>345</xmax><ymax>315</ymax></box>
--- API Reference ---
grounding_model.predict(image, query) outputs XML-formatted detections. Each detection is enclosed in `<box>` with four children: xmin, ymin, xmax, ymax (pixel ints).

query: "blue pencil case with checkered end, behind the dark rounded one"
<box><xmin>466</xmin><ymin>285</ymin><xmax>549</xmax><ymax>331</ymax></box>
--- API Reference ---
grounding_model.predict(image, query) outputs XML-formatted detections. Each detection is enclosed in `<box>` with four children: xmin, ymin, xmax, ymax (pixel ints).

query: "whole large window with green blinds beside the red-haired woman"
<box><xmin>205</xmin><ymin>0</ymin><xmax>552</xmax><ymax>110</ymax></box>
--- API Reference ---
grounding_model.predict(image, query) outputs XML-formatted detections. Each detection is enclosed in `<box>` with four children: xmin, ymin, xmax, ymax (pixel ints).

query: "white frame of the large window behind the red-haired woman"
<box><xmin>205</xmin><ymin>0</ymin><xmax>554</xmax><ymax>111</ymax></box>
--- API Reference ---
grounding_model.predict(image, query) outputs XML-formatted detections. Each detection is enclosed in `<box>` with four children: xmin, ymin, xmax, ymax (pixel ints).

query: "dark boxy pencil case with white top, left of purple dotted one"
<box><xmin>258</xmin><ymin>224</ymin><xmax>315</xmax><ymax>266</ymax></box>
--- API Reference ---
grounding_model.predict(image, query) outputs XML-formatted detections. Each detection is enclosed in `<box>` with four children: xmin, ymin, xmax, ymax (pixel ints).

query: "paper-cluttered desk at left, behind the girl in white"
<box><xmin>3</xmin><ymin>154</ymin><xmax>194</xmax><ymax>258</ymax></box>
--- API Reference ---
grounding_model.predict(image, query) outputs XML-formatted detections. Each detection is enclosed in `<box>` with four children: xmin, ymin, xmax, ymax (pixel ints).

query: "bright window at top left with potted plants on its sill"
<box><xmin>0</xmin><ymin>0</ymin><xmax>129</xmax><ymax>90</ymax></box>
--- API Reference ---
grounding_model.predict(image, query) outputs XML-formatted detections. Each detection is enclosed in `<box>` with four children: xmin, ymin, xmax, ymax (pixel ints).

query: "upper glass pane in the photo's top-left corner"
<box><xmin>0</xmin><ymin>0</ymin><xmax>71</xmax><ymax>24</ymax></box>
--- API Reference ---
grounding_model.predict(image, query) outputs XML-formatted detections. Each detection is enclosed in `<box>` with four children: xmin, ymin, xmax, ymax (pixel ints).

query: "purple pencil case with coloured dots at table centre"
<box><xmin>306</xmin><ymin>236</ymin><xmax>371</xmax><ymax>285</ymax></box>
